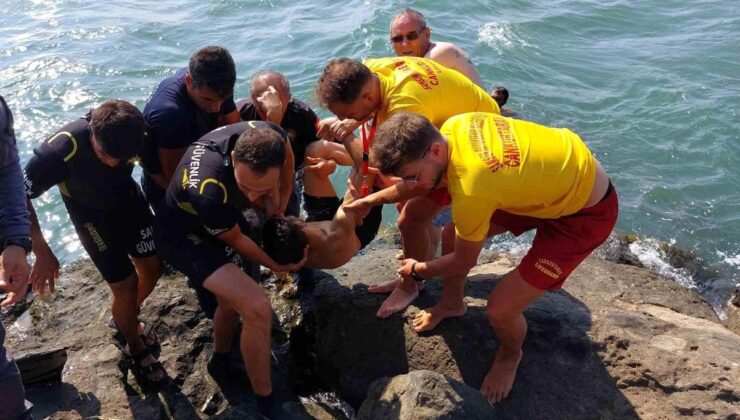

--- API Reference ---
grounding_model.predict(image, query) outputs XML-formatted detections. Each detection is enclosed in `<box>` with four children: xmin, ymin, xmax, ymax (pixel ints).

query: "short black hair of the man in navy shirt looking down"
<box><xmin>188</xmin><ymin>46</ymin><xmax>236</xmax><ymax>97</ymax></box>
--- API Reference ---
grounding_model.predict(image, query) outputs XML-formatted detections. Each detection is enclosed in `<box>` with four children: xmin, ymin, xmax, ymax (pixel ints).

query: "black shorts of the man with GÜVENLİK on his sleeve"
<box><xmin>154</xmin><ymin>210</ymin><xmax>263</xmax><ymax>318</ymax></box>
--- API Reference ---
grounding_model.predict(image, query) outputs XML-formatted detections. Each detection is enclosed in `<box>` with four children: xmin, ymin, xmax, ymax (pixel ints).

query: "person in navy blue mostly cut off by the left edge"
<box><xmin>0</xmin><ymin>96</ymin><xmax>31</xmax><ymax>419</ymax></box>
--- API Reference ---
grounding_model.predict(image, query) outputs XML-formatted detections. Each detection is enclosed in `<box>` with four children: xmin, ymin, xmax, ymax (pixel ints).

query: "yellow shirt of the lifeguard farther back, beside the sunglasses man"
<box><xmin>364</xmin><ymin>57</ymin><xmax>501</xmax><ymax>128</ymax></box>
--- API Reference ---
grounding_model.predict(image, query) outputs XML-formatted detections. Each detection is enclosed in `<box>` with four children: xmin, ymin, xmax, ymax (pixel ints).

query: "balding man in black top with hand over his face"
<box><xmin>236</xmin><ymin>71</ymin><xmax>319</xmax><ymax>216</ymax></box>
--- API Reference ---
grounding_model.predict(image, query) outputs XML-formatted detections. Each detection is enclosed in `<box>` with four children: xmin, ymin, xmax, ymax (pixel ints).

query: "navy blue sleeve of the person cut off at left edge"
<box><xmin>0</xmin><ymin>96</ymin><xmax>31</xmax><ymax>244</ymax></box>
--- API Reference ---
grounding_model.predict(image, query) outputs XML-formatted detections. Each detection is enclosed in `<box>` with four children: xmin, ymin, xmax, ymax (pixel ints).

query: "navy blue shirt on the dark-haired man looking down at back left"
<box><xmin>142</xmin><ymin>68</ymin><xmax>236</xmax><ymax>174</ymax></box>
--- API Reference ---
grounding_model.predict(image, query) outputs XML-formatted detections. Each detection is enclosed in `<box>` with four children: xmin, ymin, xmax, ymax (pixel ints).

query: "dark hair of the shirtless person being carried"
<box><xmin>262</xmin><ymin>218</ymin><xmax>308</xmax><ymax>264</ymax></box>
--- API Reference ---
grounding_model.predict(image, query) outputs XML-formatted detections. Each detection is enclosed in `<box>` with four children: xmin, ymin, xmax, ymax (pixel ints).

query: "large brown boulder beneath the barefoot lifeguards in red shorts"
<box><xmin>314</xmin><ymin>250</ymin><xmax>740</xmax><ymax>418</ymax></box>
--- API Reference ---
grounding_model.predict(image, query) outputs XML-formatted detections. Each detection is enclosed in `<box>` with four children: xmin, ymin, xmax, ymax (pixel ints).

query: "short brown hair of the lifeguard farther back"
<box><xmin>316</xmin><ymin>57</ymin><xmax>373</xmax><ymax>107</ymax></box>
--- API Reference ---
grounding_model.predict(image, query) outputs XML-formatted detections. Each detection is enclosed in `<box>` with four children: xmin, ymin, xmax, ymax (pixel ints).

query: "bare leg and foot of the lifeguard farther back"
<box><xmin>370</xmin><ymin>197</ymin><xmax>441</xmax><ymax>318</ymax></box>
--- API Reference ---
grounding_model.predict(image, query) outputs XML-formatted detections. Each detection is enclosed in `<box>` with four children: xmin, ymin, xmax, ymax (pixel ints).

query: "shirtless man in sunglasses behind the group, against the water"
<box><xmin>390</xmin><ymin>8</ymin><xmax>509</xmax><ymax>107</ymax></box>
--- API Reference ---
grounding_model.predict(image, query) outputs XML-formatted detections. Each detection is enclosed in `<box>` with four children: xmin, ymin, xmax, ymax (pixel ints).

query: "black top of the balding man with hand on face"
<box><xmin>236</xmin><ymin>98</ymin><xmax>319</xmax><ymax>171</ymax></box>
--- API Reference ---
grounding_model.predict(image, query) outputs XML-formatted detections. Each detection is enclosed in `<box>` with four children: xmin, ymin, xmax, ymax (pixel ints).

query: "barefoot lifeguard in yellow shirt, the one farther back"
<box><xmin>316</xmin><ymin>57</ymin><xmax>500</xmax><ymax>318</ymax></box>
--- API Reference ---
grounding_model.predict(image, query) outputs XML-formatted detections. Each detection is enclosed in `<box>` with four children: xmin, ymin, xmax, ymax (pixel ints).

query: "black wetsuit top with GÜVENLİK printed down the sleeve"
<box><xmin>157</xmin><ymin>121</ymin><xmax>286</xmax><ymax>236</ymax></box>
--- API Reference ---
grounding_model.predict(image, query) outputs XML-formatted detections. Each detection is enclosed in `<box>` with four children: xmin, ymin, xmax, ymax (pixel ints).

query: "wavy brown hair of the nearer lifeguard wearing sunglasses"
<box><xmin>370</xmin><ymin>112</ymin><xmax>441</xmax><ymax>175</ymax></box>
